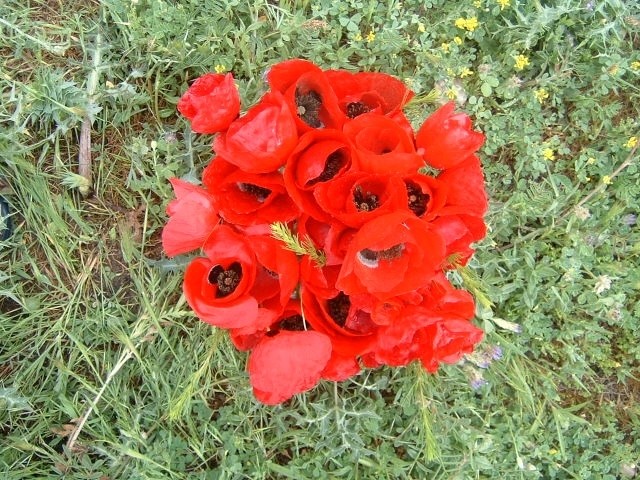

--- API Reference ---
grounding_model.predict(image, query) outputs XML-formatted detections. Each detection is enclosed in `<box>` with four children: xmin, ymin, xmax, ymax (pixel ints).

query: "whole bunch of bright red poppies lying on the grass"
<box><xmin>162</xmin><ymin>60</ymin><xmax>487</xmax><ymax>404</ymax></box>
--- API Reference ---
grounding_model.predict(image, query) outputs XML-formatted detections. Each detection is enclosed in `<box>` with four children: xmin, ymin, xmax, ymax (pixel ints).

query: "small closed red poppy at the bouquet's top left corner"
<box><xmin>178</xmin><ymin>73</ymin><xmax>240</xmax><ymax>133</ymax></box>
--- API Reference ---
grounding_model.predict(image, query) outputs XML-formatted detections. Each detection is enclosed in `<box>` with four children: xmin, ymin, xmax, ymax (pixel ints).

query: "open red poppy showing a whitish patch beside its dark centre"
<box><xmin>336</xmin><ymin>211</ymin><xmax>446</xmax><ymax>300</ymax></box>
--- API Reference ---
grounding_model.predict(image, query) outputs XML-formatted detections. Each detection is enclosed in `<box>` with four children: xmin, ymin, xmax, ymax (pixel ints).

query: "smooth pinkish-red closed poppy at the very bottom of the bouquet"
<box><xmin>248</xmin><ymin>331</ymin><xmax>331</xmax><ymax>405</ymax></box>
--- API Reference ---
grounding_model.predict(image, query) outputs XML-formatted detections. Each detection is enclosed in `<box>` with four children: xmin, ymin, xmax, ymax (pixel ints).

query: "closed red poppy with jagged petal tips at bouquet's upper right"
<box><xmin>416</xmin><ymin>102</ymin><xmax>484</xmax><ymax>169</ymax></box>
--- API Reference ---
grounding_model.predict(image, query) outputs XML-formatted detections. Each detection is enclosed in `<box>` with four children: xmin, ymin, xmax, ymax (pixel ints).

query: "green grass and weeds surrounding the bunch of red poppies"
<box><xmin>0</xmin><ymin>0</ymin><xmax>640</xmax><ymax>479</ymax></box>
